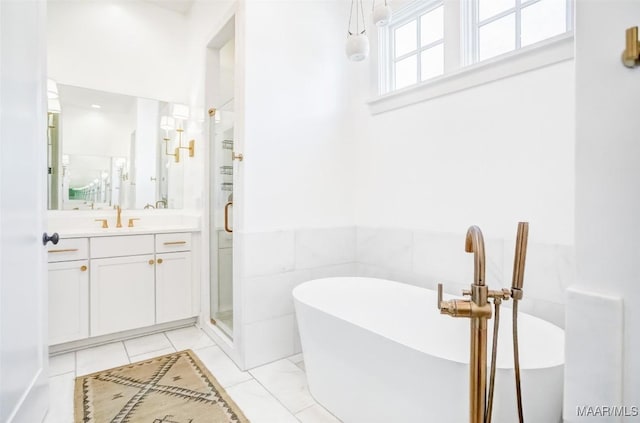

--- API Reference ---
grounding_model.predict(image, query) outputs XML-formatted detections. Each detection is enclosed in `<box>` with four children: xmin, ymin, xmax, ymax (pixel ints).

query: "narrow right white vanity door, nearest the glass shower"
<box><xmin>156</xmin><ymin>251</ymin><xmax>192</xmax><ymax>323</ymax></box>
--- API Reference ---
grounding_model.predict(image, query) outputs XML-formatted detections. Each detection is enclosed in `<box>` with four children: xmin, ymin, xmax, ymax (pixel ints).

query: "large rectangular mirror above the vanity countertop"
<box><xmin>47</xmin><ymin>81</ymin><xmax>184</xmax><ymax>210</ymax></box>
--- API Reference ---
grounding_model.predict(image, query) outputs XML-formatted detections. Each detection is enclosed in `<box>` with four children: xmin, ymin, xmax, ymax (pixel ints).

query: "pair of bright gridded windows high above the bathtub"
<box><xmin>378</xmin><ymin>0</ymin><xmax>574</xmax><ymax>98</ymax></box>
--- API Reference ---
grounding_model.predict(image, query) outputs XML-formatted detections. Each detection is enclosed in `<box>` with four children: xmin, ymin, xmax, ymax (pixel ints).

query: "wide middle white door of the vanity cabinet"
<box><xmin>91</xmin><ymin>254</ymin><xmax>155</xmax><ymax>336</ymax></box>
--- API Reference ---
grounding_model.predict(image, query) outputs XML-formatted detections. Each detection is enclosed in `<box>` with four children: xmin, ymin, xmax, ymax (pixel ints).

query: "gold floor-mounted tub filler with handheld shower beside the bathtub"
<box><xmin>438</xmin><ymin>222</ymin><xmax>529</xmax><ymax>423</ymax></box>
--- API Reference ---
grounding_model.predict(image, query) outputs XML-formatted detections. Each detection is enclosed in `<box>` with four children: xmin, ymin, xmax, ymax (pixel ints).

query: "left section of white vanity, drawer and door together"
<box><xmin>47</xmin><ymin>238</ymin><xmax>89</xmax><ymax>345</ymax></box>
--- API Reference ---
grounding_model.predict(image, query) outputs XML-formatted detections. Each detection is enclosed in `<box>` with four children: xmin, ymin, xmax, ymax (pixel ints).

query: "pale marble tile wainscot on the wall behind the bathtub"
<box><xmin>236</xmin><ymin>227</ymin><xmax>575</xmax><ymax>368</ymax></box>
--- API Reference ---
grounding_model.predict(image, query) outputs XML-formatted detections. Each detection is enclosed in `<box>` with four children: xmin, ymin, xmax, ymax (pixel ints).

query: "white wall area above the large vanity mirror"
<box><xmin>47</xmin><ymin>1</ymin><xmax>190</xmax><ymax>103</ymax></box>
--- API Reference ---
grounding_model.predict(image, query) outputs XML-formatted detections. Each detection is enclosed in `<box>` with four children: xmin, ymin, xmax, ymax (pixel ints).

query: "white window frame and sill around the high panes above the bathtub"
<box><xmin>367</xmin><ymin>0</ymin><xmax>575</xmax><ymax>114</ymax></box>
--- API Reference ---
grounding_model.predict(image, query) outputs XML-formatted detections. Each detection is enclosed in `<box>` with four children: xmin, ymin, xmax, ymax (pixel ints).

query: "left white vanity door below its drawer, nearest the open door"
<box><xmin>48</xmin><ymin>260</ymin><xmax>89</xmax><ymax>345</ymax></box>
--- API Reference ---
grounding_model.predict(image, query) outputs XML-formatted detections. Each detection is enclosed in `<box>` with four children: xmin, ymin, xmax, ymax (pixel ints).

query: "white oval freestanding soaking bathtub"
<box><xmin>293</xmin><ymin>277</ymin><xmax>564</xmax><ymax>423</ymax></box>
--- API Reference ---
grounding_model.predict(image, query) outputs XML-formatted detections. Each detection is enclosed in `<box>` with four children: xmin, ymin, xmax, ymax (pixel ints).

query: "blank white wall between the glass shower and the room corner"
<box><xmin>243</xmin><ymin>1</ymin><xmax>357</xmax><ymax>232</ymax></box>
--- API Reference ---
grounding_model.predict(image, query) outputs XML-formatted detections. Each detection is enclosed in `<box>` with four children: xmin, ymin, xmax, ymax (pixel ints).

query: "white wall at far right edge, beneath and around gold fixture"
<box><xmin>564</xmin><ymin>0</ymin><xmax>640</xmax><ymax>422</ymax></box>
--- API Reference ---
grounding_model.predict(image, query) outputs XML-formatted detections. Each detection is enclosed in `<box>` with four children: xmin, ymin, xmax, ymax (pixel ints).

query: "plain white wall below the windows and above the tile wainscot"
<box><xmin>356</xmin><ymin>61</ymin><xmax>575</xmax><ymax>244</ymax></box>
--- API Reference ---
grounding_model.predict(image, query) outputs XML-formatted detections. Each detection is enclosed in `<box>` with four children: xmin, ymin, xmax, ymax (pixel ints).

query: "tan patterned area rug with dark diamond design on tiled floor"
<box><xmin>74</xmin><ymin>350</ymin><xmax>249</xmax><ymax>423</ymax></box>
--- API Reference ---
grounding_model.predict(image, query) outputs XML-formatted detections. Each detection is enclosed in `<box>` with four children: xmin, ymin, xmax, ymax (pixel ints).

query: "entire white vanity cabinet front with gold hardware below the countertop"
<box><xmin>49</xmin><ymin>233</ymin><xmax>198</xmax><ymax>345</ymax></box>
